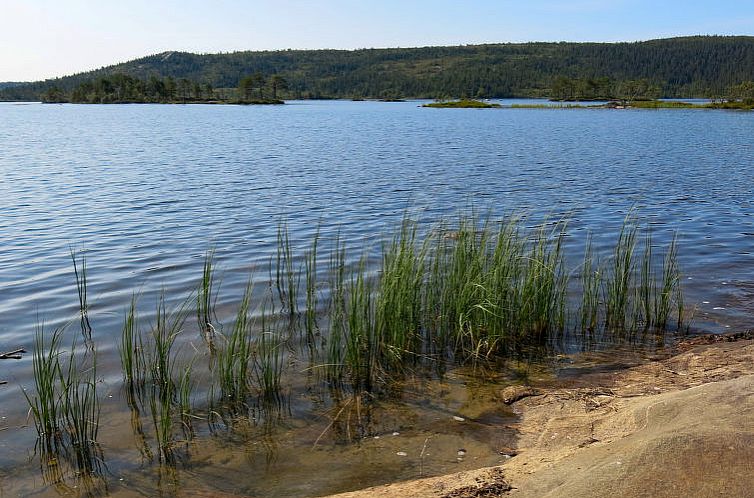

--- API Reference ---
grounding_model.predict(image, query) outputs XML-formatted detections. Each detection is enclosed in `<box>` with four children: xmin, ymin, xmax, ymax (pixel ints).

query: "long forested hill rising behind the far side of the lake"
<box><xmin>0</xmin><ymin>36</ymin><xmax>754</xmax><ymax>100</ymax></box>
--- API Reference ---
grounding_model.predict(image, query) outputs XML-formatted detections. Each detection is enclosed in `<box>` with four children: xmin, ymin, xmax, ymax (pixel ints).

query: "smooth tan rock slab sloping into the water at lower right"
<box><xmin>328</xmin><ymin>333</ymin><xmax>754</xmax><ymax>498</ymax></box>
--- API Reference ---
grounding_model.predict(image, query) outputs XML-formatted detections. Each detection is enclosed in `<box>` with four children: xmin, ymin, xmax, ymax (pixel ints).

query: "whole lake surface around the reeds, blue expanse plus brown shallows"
<box><xmin>0</xmin><ymin>102</ymin><xmax>754</xmax><ymax>495</ymax></box>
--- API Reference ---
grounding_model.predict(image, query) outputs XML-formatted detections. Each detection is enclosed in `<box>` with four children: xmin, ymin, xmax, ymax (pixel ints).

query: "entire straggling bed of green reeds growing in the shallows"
<box><xmin>26</xmin><ymin>212</ymin><xmax>688</xmax><ymax>474</ymax></box>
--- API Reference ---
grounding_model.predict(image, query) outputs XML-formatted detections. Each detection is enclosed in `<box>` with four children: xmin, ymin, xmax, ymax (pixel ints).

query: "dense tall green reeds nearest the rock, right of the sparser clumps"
<box><xmin>324</xmin><ymin>215</ymin><xmax>684</xmax><ymax>387</ymax></box>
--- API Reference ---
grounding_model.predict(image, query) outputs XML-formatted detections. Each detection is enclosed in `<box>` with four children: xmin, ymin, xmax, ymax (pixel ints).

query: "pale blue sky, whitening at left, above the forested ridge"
<box><xmin>0</xmin><ymin>0</ymin><xmax>754</xmax><ymax>81</ymax></box>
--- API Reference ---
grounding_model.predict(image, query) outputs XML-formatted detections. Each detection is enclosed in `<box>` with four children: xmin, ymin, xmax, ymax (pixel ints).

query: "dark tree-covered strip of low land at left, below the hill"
<box><xmin>41</xmin><ymin>73</ymin><xmax>287</xmax><ymax>104</ymax></box>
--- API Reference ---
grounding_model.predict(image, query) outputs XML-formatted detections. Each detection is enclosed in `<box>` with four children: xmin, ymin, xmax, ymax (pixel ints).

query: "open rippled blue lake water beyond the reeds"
<box><xmin>0</xmin><ymin>101</ymin><xmax>754</xmax><ymax>494</ymax></box>
